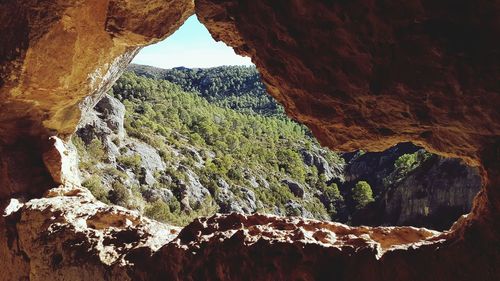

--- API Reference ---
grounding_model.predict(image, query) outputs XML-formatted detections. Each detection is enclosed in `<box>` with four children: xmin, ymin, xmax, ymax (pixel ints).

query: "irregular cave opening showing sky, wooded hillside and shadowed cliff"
<box><xmin>72</xmin><ymin>16</ymin><xmax>481</xmax><ymax>230</ymax></box>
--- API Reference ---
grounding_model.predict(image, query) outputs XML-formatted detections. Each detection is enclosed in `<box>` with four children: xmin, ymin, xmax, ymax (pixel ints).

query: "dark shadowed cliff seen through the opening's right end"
<box><xmin>348</xmin><ymin>143</ymin><xmax>481</xmax><ymax>230</ymax></box>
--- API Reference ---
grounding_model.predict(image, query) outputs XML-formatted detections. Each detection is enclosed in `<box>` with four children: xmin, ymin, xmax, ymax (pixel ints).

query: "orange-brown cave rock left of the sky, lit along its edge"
<box><xmin>0</xmin><ymin>0</ymin><xmax>194</xmax><ymax>198</ymax></box>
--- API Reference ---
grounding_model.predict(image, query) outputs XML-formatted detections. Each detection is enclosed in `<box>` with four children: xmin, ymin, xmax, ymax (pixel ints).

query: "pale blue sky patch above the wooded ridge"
<box><xmin>132</xmin><ymin>15</ymin><xmax>253</xmax><ymax>68</ymax></box>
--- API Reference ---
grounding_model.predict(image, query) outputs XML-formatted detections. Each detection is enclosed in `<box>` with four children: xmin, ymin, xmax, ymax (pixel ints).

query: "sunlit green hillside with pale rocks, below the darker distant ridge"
<box><xmin>74</xmin><ymin>69</ymin><xmax>343</xmax><ymax>224</ymax></box>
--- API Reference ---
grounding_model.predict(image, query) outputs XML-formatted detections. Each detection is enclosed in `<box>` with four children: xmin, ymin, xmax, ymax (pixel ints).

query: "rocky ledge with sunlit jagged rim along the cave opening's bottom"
<box><xmin>0</xmin><ymin>186</ymin><xmax>444</xmax><ymax>280</ymax></box>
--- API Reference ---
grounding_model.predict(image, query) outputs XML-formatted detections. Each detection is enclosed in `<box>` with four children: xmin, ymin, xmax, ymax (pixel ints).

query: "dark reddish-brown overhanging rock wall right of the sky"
<box><xmin>196</xmin><ymin>0</ymin><xmax>500</xmax><ymax>237</ymax></box>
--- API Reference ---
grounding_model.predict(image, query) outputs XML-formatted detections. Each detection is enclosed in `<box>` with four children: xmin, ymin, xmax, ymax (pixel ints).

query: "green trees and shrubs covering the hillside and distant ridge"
<box><xmin>73</xmin><ymin>67</ymin><xmax>343</xmax><ymax>225</ymax></box>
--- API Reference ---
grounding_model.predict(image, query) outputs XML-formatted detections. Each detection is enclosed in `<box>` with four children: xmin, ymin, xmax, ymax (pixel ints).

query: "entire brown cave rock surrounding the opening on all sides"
<box><xmin>0</xmin><ymin>0</ymin><xmax>500</xmax><ymax>280</ymax></box>
